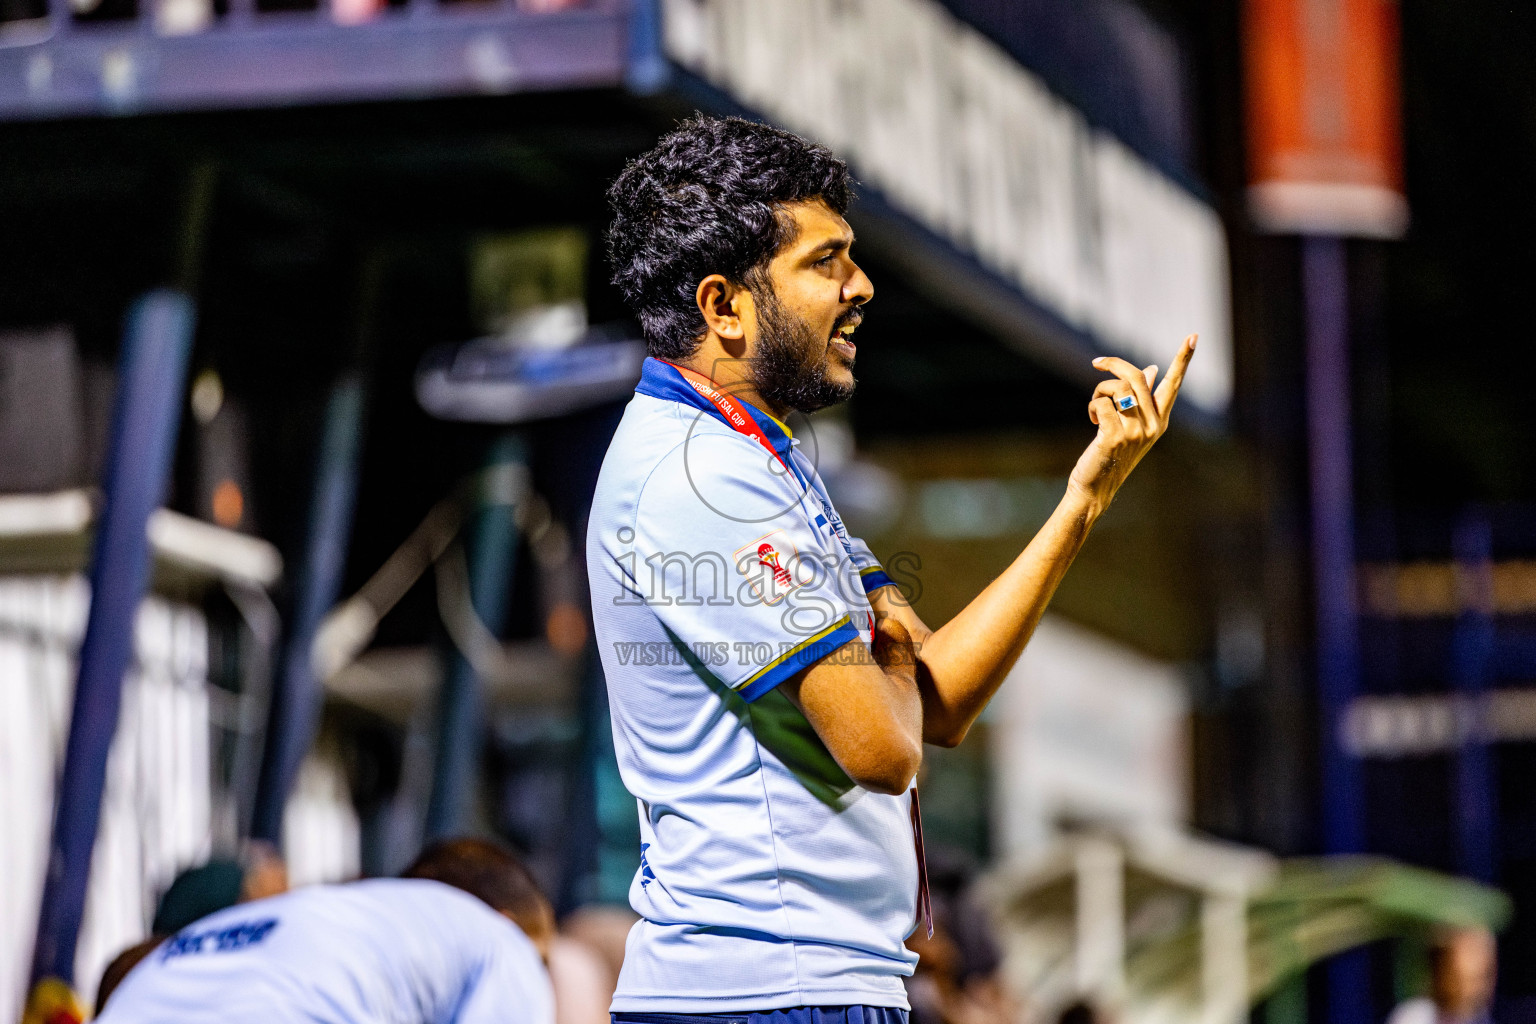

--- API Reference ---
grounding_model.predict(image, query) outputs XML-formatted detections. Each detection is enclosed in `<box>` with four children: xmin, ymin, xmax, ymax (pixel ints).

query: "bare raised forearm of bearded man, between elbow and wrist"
<box><xmin>919</xmin><ymin>487</ymin><xmax>1103</xmax><ymax>746</ymax></box>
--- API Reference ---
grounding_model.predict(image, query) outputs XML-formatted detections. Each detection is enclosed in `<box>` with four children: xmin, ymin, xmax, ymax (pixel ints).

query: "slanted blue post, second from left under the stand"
<box><xmin>250</xmin><ymin>372</ymin><xmax>367</xmax><ymax>844</ymax></box>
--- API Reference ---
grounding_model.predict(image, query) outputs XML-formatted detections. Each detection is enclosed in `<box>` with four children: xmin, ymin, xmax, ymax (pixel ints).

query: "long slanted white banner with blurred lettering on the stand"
<box><xmin>664</xmin><ymin>0</ymin><xmax>1232</xmax><ymax>413</ymax></box>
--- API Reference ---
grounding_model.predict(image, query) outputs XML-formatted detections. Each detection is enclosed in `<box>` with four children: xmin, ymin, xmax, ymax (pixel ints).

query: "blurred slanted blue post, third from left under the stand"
<box><xmin>425</xmin><ymin>433</ymin><xmax>528</xmax><ymax>841</ymax></box>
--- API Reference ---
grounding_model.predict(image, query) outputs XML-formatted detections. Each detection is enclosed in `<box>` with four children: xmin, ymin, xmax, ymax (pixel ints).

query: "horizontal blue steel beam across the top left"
<box><xmin>0</xmin><ymin>0</ymin><xmax>630</xmax><ymax>121</ymax></box>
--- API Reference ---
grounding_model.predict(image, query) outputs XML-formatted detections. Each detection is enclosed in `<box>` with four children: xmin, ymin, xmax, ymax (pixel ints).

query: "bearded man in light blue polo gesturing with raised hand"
<box><xmin>587</xmin><ymin>117</ymin><xmax>1195</xmax><ymax>1024</ymax></box>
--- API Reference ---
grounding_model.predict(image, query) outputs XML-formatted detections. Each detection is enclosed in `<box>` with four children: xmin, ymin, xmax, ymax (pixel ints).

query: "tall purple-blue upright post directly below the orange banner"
<box><xmin>1301</xmin><ymin>236</ymin><xmax>1372</xmax><ymax>1024</ymax></box>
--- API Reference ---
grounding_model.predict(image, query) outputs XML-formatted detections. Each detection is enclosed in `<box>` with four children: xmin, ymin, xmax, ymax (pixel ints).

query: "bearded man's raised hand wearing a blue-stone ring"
<box><xmin>1068</xmin><ymin>335</ymin><xmax>1197</xmax><ymax>511</ymax></box>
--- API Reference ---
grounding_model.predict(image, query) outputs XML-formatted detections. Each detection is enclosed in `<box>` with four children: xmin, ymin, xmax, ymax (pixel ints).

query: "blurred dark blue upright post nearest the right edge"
<box><xmin>1452</xmin><ymin>511</ymin><xmax>1498</xmax><ymax>884</ymax></box>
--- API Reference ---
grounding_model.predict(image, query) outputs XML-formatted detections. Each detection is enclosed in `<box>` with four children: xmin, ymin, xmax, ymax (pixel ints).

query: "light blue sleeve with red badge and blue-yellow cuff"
<box><xmin>621</xmin><ymin>433</ymin><xmax>862</xmax><ymax>702</ymax></box>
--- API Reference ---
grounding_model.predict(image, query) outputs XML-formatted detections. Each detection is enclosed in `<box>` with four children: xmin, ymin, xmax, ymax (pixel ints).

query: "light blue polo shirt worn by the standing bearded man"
<box><xmin>587</xmin><ymin>359</ymin><xmax>917</xmax><ymax>1013</ymax></box>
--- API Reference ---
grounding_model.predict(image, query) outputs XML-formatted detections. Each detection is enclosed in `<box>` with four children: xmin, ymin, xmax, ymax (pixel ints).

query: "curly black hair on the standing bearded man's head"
<box><xmin>608</xmin><ymin>114</ymin><xmax>852</xmax><ymax>359</ymax></box>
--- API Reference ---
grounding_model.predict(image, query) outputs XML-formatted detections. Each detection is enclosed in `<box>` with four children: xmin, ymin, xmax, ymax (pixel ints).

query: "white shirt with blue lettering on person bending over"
<box><xmin>98</xmin><ymin>878</ymin><xmax>554</xmax><ymax>1024</ymax></box>
